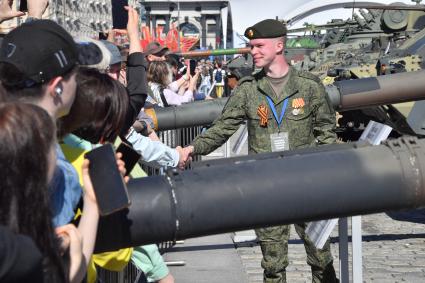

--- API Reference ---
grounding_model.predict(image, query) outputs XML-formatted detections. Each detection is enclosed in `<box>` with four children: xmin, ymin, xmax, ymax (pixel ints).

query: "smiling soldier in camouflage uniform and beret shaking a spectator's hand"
<box><xmin>185</xmin><ymin>20</ymin><xmax>337</xmax><ymax>283</ymax></box>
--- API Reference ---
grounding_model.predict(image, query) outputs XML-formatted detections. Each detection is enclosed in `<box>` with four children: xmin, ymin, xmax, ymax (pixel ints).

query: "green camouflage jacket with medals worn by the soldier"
<box><xmin>192</xmin><ymin>68</ymin><xmax>336</xmax><ymax>155</ymax></box>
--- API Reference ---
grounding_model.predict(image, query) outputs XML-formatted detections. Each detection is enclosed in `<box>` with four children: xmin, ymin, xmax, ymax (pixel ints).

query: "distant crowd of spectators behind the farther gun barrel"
<box><xmin>145</xmin><ymin>42</ymin><xmax>240</xmax><ymax>104</ymax></box>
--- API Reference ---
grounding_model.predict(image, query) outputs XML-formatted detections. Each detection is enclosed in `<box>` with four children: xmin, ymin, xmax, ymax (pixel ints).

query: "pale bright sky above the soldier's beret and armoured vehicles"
<box><xmin>229</xmin><ymin>0</ymin><xmax>414</xmax><ymax>47</ymax></box>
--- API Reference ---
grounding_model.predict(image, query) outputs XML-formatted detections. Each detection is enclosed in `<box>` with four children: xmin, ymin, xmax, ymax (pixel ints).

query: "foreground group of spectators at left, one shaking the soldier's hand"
<box><xmin>0</xmin><ymin>0</ymin><xmax>181</xmax><ymax>282</ymax></box>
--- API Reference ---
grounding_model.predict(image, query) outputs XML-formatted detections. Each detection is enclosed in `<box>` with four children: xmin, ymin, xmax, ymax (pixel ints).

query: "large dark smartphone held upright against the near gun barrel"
<box><xmin>85</xmin><ymin>144</ymin><xmax>131</xmax><ymax>216</ymax></box>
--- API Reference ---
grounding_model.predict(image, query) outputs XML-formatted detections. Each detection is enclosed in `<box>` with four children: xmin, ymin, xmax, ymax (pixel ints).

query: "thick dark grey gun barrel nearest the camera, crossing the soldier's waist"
<box><xmin>96</xmin><ymin>137</ymin><xmax>425</xmax><ymax>252</ymax></box>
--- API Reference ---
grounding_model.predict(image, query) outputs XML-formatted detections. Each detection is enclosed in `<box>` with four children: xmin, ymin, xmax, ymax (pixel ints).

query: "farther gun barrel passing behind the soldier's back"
<box><xmin>147</xmin><ymin>70</ymin><xmax>425</xmax><ymax>130</ymax></box>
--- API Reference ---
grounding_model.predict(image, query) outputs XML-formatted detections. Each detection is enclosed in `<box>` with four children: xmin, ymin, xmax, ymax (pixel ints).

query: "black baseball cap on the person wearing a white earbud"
<box><xmin>0</xmin><ymin>20</ymin><xmax>102</xmax><ymax>87</ymax></box>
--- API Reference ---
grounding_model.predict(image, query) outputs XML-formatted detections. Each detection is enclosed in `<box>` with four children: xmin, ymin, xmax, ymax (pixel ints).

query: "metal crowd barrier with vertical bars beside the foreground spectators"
<box><xmin>97</xmin><ymin>127</ymin><xmax>203</xmax><ymax>283</ymax></box>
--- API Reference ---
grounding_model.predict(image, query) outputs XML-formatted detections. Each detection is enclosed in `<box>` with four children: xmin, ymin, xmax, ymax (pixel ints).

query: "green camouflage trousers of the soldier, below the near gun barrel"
<box><xmin>255</xmin><ymin>223</ymin><xmax>338</xmax><ymax>283</ymax></box>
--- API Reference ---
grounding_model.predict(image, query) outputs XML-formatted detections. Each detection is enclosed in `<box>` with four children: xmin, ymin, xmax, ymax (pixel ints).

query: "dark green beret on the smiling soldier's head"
<box><xmin>244</xmin><ymin>19</ymin><xmax>287</xmax><ymax>39</ymax></box>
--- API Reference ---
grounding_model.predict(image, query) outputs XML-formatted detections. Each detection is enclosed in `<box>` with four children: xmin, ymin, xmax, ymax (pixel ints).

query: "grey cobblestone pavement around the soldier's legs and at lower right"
<box><xmin>238</xmin><ymin>211</ymin><xmax>425</xmax><ymax>283</ymax></box>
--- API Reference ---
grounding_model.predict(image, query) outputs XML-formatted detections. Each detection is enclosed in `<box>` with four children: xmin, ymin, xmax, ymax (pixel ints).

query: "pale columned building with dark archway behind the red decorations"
<box><xmin>140</xmin><ymin>0</ymin><xmax>233</xmax><ymax>49</ymax></box>
